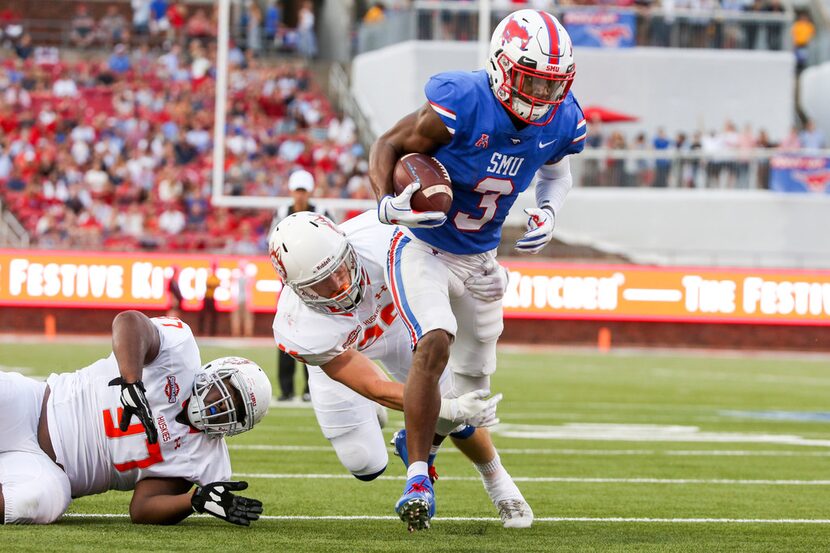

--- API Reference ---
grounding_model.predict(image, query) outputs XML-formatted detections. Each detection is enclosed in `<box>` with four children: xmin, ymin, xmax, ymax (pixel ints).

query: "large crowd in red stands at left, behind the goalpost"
<box><xmin>0</xmin><ymin>39</ymin><xmax>370</xmax><ymax>254</ymax></box>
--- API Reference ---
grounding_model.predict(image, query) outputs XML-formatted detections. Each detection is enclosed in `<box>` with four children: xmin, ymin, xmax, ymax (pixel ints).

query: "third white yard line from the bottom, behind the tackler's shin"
<box><xmin>228</xmin><ymin>444</ymin><xmax>830</xmax><ymax>457</ymax></box>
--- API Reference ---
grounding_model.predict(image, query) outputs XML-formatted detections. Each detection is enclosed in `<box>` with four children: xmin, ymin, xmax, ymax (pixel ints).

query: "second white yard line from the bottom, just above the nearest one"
<box><xmin>234</xmin><ymin>472</ymin><xmax>830</xmax><ymax>486</ymax></box>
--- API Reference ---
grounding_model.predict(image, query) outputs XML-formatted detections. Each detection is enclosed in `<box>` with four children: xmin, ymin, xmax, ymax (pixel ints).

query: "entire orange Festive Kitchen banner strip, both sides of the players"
<box><xmin>0</xmin><ymin>250</ymin><xmax>830</xmax><ymax>325</ymax></box>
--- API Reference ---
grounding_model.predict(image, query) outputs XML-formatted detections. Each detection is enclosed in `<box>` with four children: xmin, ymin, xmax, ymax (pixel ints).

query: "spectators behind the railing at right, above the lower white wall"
<box><xmin>580</xmin><ymin>119</ymin><xmax>828</xmax><ymax>188</ymax></box>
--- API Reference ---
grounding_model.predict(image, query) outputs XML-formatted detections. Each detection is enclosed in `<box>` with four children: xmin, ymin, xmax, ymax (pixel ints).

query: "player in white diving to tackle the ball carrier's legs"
<box><xmin>269</xmin><ymin>211</ymin><xmax>533</xmax><ymax>528</ymax></box>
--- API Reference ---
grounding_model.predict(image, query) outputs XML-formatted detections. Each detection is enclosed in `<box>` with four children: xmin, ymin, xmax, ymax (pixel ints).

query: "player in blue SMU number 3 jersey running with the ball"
<box><xmin>369</xmin><ymin>10</ymin><xmax>587</xmax><ymax>530</ymax></box>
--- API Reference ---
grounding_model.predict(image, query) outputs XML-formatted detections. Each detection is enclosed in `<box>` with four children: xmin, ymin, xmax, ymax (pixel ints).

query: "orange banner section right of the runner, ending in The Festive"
<box><xmin>504</xmin><ymin>263</ymin><xmax>830</xmax><ymax>325</ymax></box>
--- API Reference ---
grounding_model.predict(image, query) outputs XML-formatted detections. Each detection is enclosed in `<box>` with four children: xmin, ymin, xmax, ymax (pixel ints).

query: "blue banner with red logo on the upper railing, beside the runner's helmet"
<box><xmin>562</xmin><ymin>10</ymin><xmax>637</xmax><ymax>48</ymax></box>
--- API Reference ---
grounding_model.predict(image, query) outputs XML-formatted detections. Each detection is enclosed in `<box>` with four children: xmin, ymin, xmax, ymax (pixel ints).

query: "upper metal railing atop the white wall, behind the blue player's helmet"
<box><xmin>357</xmin><ymin>0</ymin><xmax>793</xmax><ymax>53</ymax></box>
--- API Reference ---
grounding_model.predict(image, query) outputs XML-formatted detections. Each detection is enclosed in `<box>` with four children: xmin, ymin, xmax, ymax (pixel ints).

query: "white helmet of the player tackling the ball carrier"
<box><xmin>268</xmin><ymin>211</ymin><xmax>366</xmax><ymax>314</ymax></box>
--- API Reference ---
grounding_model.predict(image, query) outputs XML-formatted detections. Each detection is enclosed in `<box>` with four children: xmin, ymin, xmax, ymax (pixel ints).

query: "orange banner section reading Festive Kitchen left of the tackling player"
<box><xmin>0</xmin><ymin>250</ymin><xmax>282</xmax><ymax>312</ymax></box>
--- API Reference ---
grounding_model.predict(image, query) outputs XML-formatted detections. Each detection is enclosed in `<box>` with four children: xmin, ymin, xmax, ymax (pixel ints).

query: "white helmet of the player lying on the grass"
<box><xmin>187</xmin><ymin>357</ymin><xmax>271</xmax><ymax>437</ymax></box>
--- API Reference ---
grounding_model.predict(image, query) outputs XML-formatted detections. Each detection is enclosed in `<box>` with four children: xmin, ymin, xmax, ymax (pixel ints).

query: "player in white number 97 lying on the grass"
<box><xmin>0</xmin><ymin>311</ymin><xmax>271</xmax><ymax>526</ymax></box>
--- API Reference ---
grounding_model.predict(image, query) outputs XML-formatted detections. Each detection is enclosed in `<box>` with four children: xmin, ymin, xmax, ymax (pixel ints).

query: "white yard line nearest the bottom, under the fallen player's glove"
<box><xmin>63</xmin><ymin>513</ymin><xmax>830</xmax><ymax>524</ymax></box>
